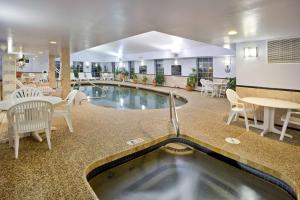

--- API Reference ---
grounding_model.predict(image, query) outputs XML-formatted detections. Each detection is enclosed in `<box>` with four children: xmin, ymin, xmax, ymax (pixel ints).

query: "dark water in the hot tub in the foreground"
<box><xmin>89</xmin><ymin>145</ymin><xmax>293</xmax><ymax>200</ymax></box>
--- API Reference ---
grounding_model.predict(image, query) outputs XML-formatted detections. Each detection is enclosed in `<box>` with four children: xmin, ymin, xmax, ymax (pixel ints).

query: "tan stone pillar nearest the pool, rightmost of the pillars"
<box><xmin>60</xmin><ymin>46</ymin><xmax>71</xmax><ymax>98</ymax></box>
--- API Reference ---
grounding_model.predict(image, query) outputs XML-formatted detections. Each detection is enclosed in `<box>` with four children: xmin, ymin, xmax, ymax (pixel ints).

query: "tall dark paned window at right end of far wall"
<box><xmin>197</xmin><ymin>57</ymin><xmax>213</xmax><ymax>86</ymax></box>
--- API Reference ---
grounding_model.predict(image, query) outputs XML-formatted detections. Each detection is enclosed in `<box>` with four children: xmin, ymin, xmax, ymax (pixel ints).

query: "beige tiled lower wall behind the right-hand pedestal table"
<box><xmin>236</xmin><ymin>87</ymin><xmax>300</xmax><ymax>128</ymax></box>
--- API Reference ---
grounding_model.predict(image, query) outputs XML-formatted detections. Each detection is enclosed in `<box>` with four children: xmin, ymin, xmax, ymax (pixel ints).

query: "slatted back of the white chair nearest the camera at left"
<box><xmin>7</xmin><ymin>101</ymin><xmax>53</xmax><ymax>133</ymax></box>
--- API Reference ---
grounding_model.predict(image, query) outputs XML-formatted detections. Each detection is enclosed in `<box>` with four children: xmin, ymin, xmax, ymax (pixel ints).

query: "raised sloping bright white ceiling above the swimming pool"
<box><xmin>72</xmin><ymin>31</ymin><xmax>235</xmax><ymax>62</ymax></box>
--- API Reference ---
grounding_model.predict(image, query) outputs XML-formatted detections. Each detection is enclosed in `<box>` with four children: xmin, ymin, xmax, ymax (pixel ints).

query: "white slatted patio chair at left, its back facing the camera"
<box><xmin>7</xmin><ymin>101</ymin><xmax>53</xmax><ymax>159</ymax></box>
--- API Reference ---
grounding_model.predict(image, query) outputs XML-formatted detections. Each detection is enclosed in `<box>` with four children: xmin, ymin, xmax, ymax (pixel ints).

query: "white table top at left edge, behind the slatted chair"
<box><xmin>0</xmin><ymin>96</ymin><xmax>63</xmax><ymax>110</ymax></box>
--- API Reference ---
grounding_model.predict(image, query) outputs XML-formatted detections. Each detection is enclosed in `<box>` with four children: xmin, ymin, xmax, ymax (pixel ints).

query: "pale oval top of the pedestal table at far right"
<box><xmin>242</xmin><ymin>97</ymin><xmax>300</xmax><ymax>109</ymax></box>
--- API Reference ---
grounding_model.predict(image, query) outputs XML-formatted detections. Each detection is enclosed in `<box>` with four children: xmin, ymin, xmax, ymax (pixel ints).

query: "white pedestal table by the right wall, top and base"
<box><xmin>242</xmin><ymin>97</ymin><xmax>300</xmax><ymax>138</ymax></box>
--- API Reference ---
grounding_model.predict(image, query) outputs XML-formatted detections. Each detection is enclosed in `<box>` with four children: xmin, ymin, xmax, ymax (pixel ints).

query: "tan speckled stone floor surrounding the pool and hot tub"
<box><xmin>0</xmin><ymin>81</ymin><xmax>300</xmax><ymax>200</ymax></box>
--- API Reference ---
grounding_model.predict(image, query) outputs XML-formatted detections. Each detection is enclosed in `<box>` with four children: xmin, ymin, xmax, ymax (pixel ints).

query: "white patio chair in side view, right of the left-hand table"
<box><xmin>53</xmin><ymin>90</ymin><xmax>78</xmax><ymax>133</ymax></box>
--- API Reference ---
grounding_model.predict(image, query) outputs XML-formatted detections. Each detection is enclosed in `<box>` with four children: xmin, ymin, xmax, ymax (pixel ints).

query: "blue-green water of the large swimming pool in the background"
<box><xmin>79</xmin><ymin>85</ymin><xmax>186</xmax><ymax>110</ymax></box>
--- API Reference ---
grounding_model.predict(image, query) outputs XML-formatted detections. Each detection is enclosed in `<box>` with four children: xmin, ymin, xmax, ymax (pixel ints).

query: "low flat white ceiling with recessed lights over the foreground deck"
<box><xmin>0</xmin><ymin>0</ymin><xmax>300</xmax><ymax>53</ymax></box>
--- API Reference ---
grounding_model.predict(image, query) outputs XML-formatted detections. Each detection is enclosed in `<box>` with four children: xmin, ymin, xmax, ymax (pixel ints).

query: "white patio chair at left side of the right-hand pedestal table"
<box><xmin>226</xmin><ymin>89</ymin><xmax>257</xmax><ymax>131</ymax></box>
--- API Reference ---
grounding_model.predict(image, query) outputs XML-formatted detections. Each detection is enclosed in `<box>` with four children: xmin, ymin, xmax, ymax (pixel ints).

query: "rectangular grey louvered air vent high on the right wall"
<box><xmin>268</xmin><ymin>38</ymin><xmax>300</xmax><ymax>63</ymax></box>
